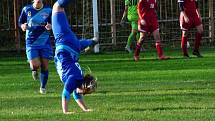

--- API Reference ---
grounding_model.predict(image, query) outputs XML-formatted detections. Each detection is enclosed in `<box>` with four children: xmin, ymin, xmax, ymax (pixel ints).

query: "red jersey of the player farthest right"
<box><xmin>178</xmin><ymin>0</ymin><xmax>197</xmax><ymax>13</ymax></box>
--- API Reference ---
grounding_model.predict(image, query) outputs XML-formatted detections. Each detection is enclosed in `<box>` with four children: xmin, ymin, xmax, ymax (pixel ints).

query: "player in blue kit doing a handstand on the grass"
<box><xmin>52</xmin><ymin>0</ymin><xmax>96</xmax><ymax>114</ymax></box>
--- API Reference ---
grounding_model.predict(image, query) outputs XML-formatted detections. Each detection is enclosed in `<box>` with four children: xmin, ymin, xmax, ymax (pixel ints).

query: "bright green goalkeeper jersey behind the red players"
<box><xmin>125</xmin><ymin>0</ymin><xmax>139</xmax><ymax>21</ymax></box>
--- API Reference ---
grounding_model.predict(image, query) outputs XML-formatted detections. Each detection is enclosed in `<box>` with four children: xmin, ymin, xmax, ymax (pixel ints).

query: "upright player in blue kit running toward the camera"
<box><xmin>19</xmin><ymin>0</ymin><xmax>53</xmax><ymax>94</ymax></box>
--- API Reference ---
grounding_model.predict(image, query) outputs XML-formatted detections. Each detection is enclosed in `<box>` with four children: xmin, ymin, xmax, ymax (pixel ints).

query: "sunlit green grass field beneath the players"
<box><xmin>0</xmin><ymin>50</ymin><xmax>215</xmax><ymax>121</ymax></box>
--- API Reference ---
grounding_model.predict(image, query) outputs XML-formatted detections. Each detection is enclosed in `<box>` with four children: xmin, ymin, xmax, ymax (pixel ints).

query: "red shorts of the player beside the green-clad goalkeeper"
<box><xmin>138</xmin><ymin>17</ymin><xmax>159</xmax><ymax>33</ymax></box>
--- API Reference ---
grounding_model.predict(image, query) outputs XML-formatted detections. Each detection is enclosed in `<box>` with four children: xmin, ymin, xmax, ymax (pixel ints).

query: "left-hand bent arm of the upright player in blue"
<box><xmin>18</xmin><ymin>7</ymin><xmax>27</xmax><ymax>31</ymax></box>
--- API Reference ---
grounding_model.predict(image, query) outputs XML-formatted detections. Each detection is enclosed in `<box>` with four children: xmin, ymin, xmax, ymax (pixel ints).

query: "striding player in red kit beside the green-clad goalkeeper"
<box><xmin>134</xmin><ymin>0</ymin><xmax>169</xmax><ymax>61</ymax></box>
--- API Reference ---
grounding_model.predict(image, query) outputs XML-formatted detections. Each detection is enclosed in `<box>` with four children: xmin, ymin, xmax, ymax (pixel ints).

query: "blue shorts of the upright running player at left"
<box><xmin>26</xmin><ymin>48</ymin><xmax>53</xmax><ymax>60</ymax></box>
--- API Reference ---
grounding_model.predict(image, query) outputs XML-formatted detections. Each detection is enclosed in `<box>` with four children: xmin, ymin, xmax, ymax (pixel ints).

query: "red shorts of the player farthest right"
<box><xmin>180</xmin><ymin>12</ymin><xmax>202</xmax><ymax>30</ymax></box>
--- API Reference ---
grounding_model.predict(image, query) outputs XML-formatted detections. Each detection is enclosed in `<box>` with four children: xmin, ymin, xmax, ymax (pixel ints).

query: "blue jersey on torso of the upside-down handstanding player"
<box><xmin>55</xmin><ymin>50</ymin><xmax>83</xmax><ymax>93</ymax></box>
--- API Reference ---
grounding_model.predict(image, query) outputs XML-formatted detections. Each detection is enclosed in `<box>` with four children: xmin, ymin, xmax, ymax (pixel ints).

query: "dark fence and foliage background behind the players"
<box><xmin>0</xmin><ymin>0</ymin><xmax>215</xmax><ymax>52</ymax></box>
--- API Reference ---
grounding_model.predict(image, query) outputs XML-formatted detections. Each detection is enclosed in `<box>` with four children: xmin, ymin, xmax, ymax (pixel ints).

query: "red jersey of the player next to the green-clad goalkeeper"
<box><xmin>138</xmin><ymin>0</ymin><xmax>157</xmax><ymax>19</ymax></box>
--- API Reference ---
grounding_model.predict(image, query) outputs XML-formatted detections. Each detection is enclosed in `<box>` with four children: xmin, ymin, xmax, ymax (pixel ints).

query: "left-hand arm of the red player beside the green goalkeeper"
<box><xmin>137</xmin><ymin>0</ymin><xmax>146</xmax><ymax>25</ymax></box>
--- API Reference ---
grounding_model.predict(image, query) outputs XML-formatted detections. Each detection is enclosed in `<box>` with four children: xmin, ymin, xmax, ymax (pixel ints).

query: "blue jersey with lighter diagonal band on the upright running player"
<box><xmin>19</xmin><ymin>5</ymin><xmax>52</xmax><ymax>49</ymax></box>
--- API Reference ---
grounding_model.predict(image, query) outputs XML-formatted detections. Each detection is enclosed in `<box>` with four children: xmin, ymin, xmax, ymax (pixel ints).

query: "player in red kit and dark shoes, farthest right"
<box><xmin>178</xmin><ymin>0</ymin><xmax>203</xmax><ymax>58</ymax></box>
